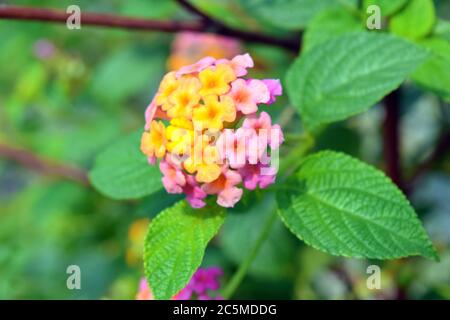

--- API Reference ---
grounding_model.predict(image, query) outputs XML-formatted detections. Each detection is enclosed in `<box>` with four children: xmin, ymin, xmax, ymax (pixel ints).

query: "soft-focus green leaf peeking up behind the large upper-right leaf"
<box><xmin>303</xmin><ymin>8</ymin><xmax>364</xmax><ymax>51</ymax></box>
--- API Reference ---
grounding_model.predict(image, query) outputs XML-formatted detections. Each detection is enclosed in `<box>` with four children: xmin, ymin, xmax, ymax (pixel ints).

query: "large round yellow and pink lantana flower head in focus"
<box><xmin>141</xmin><ymin>54</ymin><xmax>283</xmax><ymax>208</ymax></box>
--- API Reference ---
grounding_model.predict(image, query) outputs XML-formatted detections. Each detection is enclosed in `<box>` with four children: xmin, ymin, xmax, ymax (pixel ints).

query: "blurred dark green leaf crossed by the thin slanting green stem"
<box><xmin>220</xmin><ymin>194</ymin><xmax>294</xmax><ymax>278</ymax></box>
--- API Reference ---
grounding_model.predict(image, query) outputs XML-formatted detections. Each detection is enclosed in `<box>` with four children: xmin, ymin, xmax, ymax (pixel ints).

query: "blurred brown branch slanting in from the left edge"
<box><xmin>0</xmin><ymin>144</ymin><xmax>89</xmax><ymax>186</ymax></box>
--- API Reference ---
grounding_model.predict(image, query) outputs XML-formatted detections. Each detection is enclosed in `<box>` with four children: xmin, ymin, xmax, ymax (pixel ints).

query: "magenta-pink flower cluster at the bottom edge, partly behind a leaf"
<box><xmin>136</xmin><ymin>267</ymin><xmax>223</xmax><ymax>300</ymax></box>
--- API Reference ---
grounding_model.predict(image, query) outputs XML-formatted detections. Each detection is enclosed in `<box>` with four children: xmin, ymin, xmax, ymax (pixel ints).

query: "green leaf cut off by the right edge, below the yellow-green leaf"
<box><xmin>412</xmin><ymin>37</ymin><xmax>450</xmax><ymax>100</ymax></box>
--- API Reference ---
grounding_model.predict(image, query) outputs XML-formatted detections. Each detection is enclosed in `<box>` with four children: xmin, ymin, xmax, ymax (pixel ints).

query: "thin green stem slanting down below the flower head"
<box><xmin>223</xmin><ymin>210</ymin><xmax>277</xmax><ymax>299</ymax></box>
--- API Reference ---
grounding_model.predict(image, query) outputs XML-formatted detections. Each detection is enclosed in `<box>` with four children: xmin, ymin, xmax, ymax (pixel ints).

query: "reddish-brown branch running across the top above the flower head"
<box><xmin>0</xmin><ymin>6</ymin><xmax>300</xmax><ymax>52</ymax></box>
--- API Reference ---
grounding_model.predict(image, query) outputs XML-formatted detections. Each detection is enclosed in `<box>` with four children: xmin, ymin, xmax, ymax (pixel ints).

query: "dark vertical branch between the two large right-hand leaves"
<box><xmin>383</xmin><ymin>89</ymin><xmax>404</xmax><ymax>190</ymax></box>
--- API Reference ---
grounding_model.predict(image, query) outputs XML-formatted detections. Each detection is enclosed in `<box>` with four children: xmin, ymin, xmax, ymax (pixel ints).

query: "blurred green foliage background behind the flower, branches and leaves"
<box><xmin>0</xmin><ymin>0</ymin><xmax>450</xmax><ymax>299</ymax></box>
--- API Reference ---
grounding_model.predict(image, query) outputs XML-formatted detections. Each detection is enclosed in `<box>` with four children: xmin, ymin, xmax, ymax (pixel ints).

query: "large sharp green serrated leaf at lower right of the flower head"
<box><xmin>277</xmin><ymin>151</ymin><xmax>437</xmax><ymax>259</ymax></box>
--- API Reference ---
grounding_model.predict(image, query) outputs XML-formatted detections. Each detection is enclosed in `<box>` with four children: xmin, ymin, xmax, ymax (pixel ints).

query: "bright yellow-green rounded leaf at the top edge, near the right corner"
<box><xmin>389</xmin><ymin>0</ymin><xmax>436</xmax><ymax>40</ymax></box>
